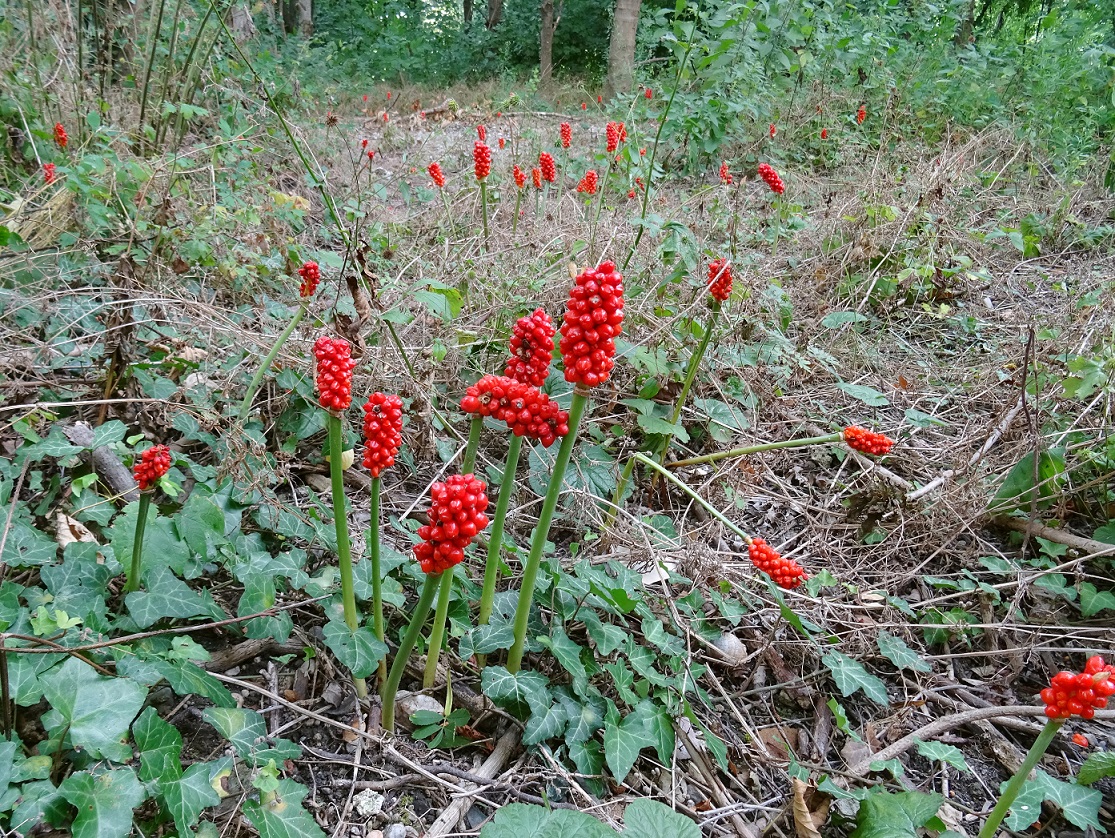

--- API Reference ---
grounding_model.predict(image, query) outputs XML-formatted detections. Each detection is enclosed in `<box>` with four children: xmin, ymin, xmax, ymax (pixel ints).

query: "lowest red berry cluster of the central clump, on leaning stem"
<box><xmin>414</xmin><ymin>475</ymin><xmax>487</xmax><ymax>573</ymax></box>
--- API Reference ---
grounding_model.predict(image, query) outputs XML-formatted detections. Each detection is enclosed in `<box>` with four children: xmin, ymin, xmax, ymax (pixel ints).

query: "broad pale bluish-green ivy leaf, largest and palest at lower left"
<box><xmin>39</xmin><ymin>657</ymin><xmax>147</xmax><ymax>762</ymax></box>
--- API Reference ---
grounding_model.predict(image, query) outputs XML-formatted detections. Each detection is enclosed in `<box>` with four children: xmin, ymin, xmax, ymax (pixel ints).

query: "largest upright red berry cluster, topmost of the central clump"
<box><xmin>559</xmin><ymin>262</ymin><xmax>623</xmax><ymax>387</ymax></box>
